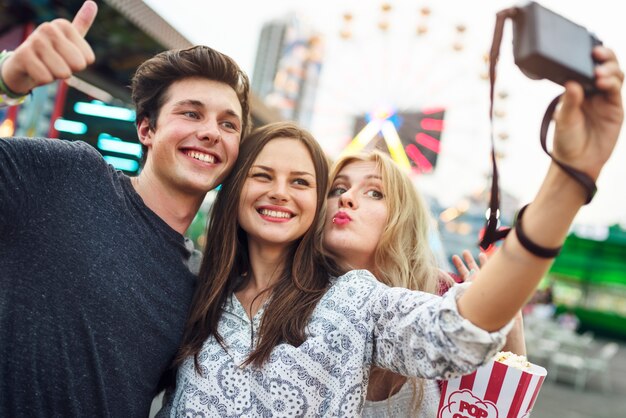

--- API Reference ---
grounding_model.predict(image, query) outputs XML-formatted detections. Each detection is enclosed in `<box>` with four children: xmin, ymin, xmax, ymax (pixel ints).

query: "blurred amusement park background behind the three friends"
<box><xmin>0</xmin><ymin>0</ymin><xmax>626</xmax><ymax>417</ymax></box>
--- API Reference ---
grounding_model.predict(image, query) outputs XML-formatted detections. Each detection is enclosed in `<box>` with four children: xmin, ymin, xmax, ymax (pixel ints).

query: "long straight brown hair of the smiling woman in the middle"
<box><xmin>175</xmin><ymin>122</ymin><xmax>330</xmax><ymax>372</ymax></box>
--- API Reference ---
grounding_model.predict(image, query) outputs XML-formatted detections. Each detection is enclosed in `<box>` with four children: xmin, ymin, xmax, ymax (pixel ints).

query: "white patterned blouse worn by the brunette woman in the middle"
<box><xmin>158</xmin><ymin>270</ymin><xmax>510</xmax><ymax>418</ymax></box>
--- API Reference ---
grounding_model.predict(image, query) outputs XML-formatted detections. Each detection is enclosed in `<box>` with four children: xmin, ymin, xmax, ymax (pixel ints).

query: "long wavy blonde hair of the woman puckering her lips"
<box><xmin>329</xmin><ymin>151</ymin><xmax>441</xmax><ymax>412</ymax></box>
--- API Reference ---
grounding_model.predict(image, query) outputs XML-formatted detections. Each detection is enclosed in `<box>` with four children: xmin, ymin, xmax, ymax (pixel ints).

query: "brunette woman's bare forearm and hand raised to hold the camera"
<box><xmin>458</xmin><ymin>47</ymin><xmax>624</xmax><ymax>331</ymax></box>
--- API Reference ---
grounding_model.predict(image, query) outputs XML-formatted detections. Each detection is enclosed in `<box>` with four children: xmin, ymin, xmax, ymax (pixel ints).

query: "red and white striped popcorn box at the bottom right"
<box><xmin>437</xmin><ymin>360</ymin><xmax>547</xmax><ymax>418</ymax></box>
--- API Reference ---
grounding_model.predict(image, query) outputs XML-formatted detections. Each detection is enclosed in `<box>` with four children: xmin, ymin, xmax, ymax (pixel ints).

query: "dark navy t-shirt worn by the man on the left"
<box><xmin>0</xmin><ymin>138</ymin><xmax>195</xmax><ymax>417</ymax></box>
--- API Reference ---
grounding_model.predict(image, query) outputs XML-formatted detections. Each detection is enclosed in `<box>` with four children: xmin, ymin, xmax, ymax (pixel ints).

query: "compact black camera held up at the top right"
<box><xmin>513</xmin><ymin>1</ymin><xmax>602</xmax><ymax>94</ymax></box>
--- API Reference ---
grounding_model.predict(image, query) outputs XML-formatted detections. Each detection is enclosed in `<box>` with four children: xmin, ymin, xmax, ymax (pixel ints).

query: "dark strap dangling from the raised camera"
<box><xmin>479</xmin><ymin>7</ymin><xmax>597</xmax><ymax>250</ymax></box>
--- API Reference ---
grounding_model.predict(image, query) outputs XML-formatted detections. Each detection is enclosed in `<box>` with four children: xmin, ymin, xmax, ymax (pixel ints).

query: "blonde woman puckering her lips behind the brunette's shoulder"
<box><xmin>324</xmin><ymin>151</ymin><xmax>525</xmax><ymax>417</ymax></box>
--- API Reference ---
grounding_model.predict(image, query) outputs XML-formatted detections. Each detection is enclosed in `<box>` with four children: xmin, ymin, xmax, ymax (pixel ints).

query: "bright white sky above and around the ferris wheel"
<box><xmin>144</xmin><ymin>0</ymin><xmax>626</xmax><ymax>228</ymax></box>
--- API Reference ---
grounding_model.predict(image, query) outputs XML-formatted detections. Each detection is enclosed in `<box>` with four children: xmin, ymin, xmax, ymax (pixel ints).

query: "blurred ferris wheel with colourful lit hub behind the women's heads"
<box><xmin>311</xmin><ymin>2</ymin><xmax>508</xmax><ymax>185</ymax></box>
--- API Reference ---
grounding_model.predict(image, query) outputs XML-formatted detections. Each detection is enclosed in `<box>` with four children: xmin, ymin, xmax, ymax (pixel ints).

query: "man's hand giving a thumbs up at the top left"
<box><xmin>0</xmin><ymin>1</ymin><xmax>98</xmax><ymax>94</ymax></box>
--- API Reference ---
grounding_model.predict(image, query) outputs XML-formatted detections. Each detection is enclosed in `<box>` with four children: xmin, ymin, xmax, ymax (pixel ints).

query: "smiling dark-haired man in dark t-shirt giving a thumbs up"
<box><xmin>0</xmin><ymin>1</ymin><xmax>249</xmax><ymax>417</ymax></box>
